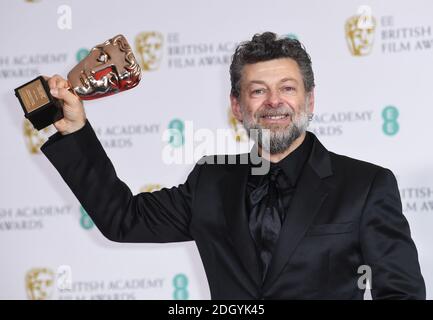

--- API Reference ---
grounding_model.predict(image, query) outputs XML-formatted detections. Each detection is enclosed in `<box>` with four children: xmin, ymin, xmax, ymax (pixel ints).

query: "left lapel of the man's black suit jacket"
<box><xmin>220</xmin><ymin>160</ymin><xmax>260</xmax><ymax>291</ymax></box>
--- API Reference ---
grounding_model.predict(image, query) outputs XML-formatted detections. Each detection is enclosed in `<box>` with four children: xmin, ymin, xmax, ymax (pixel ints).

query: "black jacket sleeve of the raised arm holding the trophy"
<box><xmin>41</xmin><ymin>121</ymin><xmax>200</xmax><ymax>243</ymax></box>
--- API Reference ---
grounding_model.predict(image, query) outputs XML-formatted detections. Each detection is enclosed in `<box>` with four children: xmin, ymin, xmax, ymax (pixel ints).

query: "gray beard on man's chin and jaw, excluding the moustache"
<box><xmin>242</xmin><ymin>99</ymin><xmax>309</xmax><ymax>154</ymax></box>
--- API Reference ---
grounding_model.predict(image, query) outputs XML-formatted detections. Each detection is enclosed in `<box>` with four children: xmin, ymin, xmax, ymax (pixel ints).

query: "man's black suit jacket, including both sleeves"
<box><xmin>42</xmin><ymin>122</ymin><xmax>425</xmax><ymax>299</ymax></box>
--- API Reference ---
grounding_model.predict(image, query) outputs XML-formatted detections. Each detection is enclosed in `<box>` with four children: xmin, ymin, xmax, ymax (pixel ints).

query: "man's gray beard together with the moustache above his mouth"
<box><xmin>241</xmin><ymin>97</ymin><xmax>309</xmax><ymax>154</ymax></box>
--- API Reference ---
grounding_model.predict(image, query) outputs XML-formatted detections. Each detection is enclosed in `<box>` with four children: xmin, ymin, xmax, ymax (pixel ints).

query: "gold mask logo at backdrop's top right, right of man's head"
<box><xmin>345</xmin><ymin>6</ymin><xmax>376</xmax><ymax>57</ymax></box>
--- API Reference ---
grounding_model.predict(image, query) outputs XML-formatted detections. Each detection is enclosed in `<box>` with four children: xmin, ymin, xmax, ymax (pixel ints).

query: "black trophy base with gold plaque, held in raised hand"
<box><xmin>15</xmin><ymin>76</ymin><xmax>63</xmax><ymax>130</ymax></box>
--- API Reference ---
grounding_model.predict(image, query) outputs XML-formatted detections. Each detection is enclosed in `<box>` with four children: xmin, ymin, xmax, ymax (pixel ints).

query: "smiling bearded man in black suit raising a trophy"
<box><xmin>42</xmin><ymin>32</ymin><xmax>425</xmax><ymax>299</ymax></box>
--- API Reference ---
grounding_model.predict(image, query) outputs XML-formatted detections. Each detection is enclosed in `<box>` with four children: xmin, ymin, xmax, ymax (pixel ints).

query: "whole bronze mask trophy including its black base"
<box><xmin>15</xmin><ymin>35</ymin><xmax>141</xmax><ymax>130</ymax></box>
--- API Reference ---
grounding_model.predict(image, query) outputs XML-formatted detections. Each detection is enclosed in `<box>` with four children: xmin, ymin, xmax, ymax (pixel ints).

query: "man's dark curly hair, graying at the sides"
<box><xmin>230</xmin><ymin>32</ymin><xmax>314</xmax><ymax>98</ymax></box>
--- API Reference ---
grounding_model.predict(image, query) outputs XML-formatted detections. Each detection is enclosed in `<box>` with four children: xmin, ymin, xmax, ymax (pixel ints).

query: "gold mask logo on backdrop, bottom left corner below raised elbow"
<box><xmin>25</xmin><ymin>268</ymin><xmax>55</xmax><ymax>300</ymax></box>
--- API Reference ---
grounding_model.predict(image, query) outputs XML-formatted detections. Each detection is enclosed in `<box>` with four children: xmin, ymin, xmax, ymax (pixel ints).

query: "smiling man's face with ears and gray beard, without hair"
<box><xmin>231</xmin><ymin>58</ymin><xmax>314</xmax><ymax>154</ymax></box>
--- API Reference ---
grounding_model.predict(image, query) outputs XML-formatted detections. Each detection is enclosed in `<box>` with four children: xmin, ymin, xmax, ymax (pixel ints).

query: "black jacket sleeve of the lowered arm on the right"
<box><xmin>360</xmin><ymin>168</ymin><xmax>426</xmax><ymax>299</ymax></box>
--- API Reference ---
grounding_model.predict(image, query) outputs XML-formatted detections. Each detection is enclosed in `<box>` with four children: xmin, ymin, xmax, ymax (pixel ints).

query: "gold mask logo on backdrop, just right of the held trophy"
<box><xmin>135</xmin><ymin>31</ymin><xmax>164</xmax><ymax>71</ymax></box>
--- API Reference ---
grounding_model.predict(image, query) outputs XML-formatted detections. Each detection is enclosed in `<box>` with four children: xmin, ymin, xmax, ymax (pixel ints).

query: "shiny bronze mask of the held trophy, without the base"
<box><xmin>68</xmin><ymin>35</ymin><xmax>141</xmax><ymax>100</ymax></box>
